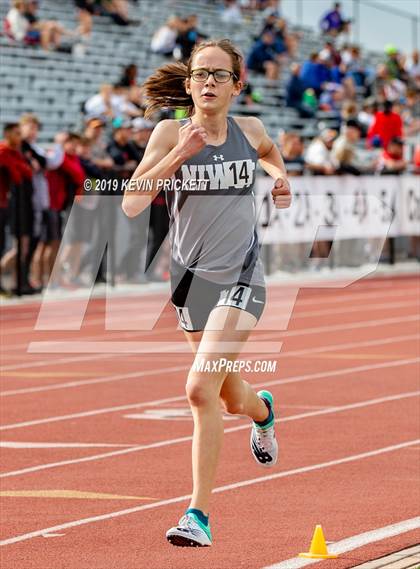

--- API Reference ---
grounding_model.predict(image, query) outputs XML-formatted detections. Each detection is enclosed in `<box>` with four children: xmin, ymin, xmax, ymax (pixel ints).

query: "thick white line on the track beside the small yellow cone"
<box><xmin>263</xmin><ymin>517</ymin><xmax>420</xmax><ymax>569</ymax></box>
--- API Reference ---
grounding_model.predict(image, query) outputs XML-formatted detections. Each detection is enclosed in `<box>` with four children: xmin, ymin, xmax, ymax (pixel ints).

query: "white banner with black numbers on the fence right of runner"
<box><xmin>256</xmin><ymin>176</ymin><xmax>420</xmax><ymax>243</ymax></box>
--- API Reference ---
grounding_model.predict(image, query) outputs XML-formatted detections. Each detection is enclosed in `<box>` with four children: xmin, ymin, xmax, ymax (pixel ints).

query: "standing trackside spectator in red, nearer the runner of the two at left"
<box><xmin>43</xmin><ymin>132</ymin><xmax>86</xmax><ymax>284</ymax></box>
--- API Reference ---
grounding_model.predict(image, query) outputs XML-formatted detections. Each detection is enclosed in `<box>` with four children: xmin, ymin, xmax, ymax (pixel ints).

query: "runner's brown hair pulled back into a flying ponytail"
<box><xmin>144</xmin><ymin>39</ymin><xmax>243</xmax><ymax>118</ymax></box>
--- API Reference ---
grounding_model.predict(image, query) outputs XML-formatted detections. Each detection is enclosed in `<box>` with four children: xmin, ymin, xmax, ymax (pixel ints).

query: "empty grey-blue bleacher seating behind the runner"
<box><xmin>0</xmin><ymin>0</ymin><xmax>348</xmax><ymax>143</ymax></box>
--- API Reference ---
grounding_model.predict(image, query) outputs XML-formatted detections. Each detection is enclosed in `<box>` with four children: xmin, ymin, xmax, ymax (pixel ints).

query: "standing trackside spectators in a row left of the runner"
<box><xmin>0</xmin><ymin>114</ymin><xmax>169</xmax><ymax>294</ymax></box>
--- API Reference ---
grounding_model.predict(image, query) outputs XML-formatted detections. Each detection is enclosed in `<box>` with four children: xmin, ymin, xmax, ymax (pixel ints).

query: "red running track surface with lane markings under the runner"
<box><xmin>0</xmin><ymin>277</ymin><xmax>420</xmax><ymax>569</ymax></box>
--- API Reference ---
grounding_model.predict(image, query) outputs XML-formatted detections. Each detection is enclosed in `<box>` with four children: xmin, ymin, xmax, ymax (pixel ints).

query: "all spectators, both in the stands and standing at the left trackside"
<box><xmin>0</xmin><ymin>0</ymin><xmax>420</xmax><ymax>294</ymax></box>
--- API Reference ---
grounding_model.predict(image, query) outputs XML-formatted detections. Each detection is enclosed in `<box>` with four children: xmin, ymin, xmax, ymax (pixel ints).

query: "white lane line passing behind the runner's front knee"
<box><xmin>0</xmin><ymin>357</ymin><xmax>420</xmax><ymax>431</ymax></box>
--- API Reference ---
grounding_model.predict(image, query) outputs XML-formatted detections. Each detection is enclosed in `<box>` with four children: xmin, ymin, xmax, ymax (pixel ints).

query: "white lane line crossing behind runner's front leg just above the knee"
<box><xmin>0</xmin><ymin>334</ymin><xmax>420</xmax><ymax>397</ymax></box>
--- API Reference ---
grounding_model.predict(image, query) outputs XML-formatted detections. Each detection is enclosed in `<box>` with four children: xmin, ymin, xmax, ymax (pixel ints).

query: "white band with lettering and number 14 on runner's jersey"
<box><xmin>181</xmin><ymin>158</ymin><xmax>255</xmax><ymax>190</ymax></box>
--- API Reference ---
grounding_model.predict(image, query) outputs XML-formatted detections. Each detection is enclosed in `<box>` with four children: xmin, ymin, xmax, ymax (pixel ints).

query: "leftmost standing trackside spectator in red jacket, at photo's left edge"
<box><xmin>0</xmin><ymin>123</ymin><xmax>33</xmax><ymax>292</ymax></box>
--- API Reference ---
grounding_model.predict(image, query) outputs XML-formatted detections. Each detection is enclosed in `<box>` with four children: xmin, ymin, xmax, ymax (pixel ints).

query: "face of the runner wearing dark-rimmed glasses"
<box><xmin>186</xmin><ymin>47</ymin><xmax>242</xmax><ymax>113</ymax></box>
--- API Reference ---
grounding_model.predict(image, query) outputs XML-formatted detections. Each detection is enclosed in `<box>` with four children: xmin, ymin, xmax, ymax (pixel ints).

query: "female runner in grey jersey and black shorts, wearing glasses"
<box><xmin>122</xmin><ymin>39</ymin><xmax>291</xmax><ymax>546</ymax></box>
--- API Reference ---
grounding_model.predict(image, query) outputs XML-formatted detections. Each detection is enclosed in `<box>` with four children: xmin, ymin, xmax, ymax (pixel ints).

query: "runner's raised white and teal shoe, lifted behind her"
<box><xmin>250</xmin><ymin>391</ymin><xmax>279</xmax><ymax>468</ymax></box>
